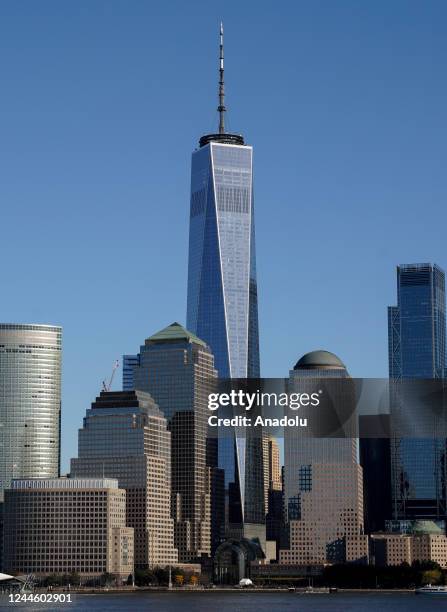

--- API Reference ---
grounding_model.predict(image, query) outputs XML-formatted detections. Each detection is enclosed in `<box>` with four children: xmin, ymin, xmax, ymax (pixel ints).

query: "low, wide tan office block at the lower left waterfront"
<box><xmin>3</xmin><ymin>478</ymin><xmax>134</xmax><ymax>583</ymax></box>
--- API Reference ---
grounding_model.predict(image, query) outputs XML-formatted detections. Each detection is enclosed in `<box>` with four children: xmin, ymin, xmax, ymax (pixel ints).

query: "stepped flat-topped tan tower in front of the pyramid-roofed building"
<box><xmin>71</xmin><ymin>391</ymin><xmax>178</xmax><ymax>569</ymax></box>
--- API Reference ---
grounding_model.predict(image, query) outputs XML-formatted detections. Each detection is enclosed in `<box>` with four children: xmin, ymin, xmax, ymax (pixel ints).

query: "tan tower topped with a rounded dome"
<box><xmin>280</xmin><ymin>351</ymin><xmax>368</xmax><ymax>565</ymax></box>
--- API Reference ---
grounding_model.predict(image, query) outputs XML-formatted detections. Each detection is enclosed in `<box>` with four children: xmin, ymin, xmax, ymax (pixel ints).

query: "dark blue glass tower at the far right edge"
<box><xmin>388</xmin><ymin>263</ymin><xmax>446</xmax><ymax>520</ymax></box>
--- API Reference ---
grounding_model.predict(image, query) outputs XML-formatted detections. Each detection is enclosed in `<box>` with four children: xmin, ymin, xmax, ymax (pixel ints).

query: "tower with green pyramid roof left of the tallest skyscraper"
<box><xmin>134</xmin><ymin>323</ymin><xmax>224</xmax><ymax>562</ymax></box>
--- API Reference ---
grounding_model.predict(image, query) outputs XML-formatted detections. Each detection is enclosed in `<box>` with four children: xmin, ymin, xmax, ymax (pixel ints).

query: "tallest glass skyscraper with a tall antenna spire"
<box><xmin>187</xmin><ymin>26</ymin><xmax>266</xmax><ymax>544</ymax></box>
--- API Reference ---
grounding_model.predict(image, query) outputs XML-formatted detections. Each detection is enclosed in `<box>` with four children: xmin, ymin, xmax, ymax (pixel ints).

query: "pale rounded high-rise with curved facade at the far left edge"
<box><xmin>0</xmin><ymin>323</ymin><xmax>62</xmax><ymax>501</ymax></box>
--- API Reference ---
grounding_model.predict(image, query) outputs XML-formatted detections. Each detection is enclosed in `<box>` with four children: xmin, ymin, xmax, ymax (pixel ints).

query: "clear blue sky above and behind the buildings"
<box><xmin>0</xmin><ymin>0</ymin><xmax>447</xmax><ymax>469</ymax></box>
